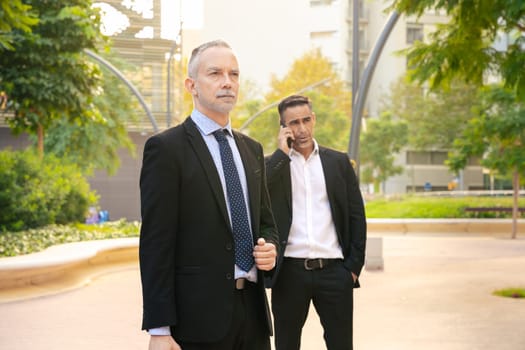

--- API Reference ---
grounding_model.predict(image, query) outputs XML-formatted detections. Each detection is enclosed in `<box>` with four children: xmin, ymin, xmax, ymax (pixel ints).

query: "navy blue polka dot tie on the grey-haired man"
<box><xmin>213</xmin><ymin>129</ymin><xmax>254</xmax><ymax>271</ymax></box>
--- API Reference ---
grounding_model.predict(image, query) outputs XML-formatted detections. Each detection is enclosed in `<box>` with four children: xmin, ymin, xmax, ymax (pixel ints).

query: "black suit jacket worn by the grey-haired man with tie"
<box><xmin>139</xmin><ymin>118</ymin><xmax>278</xmax><ymax>342</ymax></box>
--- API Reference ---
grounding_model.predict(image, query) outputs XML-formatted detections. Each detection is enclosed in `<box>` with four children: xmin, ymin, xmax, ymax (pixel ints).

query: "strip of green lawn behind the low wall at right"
<box><xmin>366</xmin><ymin>195</ymin><xmax>525</xmax><ymax>219</ymax></box>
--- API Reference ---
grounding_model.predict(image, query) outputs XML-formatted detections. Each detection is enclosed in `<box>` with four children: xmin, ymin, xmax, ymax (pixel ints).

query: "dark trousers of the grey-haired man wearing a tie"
<box><xmin>178</xmin><ymin>283</ymin><xmax>270</xmax><ymax>350</ymax></box>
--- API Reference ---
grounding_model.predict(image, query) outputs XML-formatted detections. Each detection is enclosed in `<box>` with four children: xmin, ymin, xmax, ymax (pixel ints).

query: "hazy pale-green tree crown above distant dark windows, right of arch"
<box><xmin>383</xmin><ymin>76</ymin><xmax>477</xmax><ymax>150</ymax></box>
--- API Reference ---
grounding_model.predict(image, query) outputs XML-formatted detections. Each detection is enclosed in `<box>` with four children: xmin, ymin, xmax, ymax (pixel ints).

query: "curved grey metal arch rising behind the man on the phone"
<box><xmin>348</xmin><ymin>11</ymin><xmax>399</xmax><ymax>178</ymax></box>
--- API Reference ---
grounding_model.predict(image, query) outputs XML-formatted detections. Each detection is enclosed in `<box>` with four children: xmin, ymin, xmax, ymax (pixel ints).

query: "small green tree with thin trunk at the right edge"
<box><xmin>447</xmin><ymin>86</ymin><xmax>525</xmax><ymax>238</ymax></box>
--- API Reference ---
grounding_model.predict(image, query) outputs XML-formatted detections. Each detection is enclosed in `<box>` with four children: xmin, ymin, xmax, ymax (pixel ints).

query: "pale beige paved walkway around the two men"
<box><xmin>0</xmin><ymin>235</ymin><xmax>525</xmax><ymax>350</ymax></box>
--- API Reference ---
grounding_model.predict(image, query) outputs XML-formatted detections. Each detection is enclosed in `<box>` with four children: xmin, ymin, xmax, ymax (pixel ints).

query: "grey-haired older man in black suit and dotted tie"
<box><xmin>139</xmin><ymin>40</ymin><xmax>278</xmax><ymax>350</ymax></box>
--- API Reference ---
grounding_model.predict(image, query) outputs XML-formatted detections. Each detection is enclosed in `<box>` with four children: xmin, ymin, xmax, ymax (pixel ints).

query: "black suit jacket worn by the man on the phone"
<box><xmin>266</xmin><ymin>146</ymin><xmax>366</xmax><ymax>287</ymax></box>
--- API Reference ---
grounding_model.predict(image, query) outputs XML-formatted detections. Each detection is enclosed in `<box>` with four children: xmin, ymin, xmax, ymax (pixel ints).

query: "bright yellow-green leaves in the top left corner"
<box><xmin>0</xmin><ymin>0</ymin><xmax>38</xmax><ymax>50</ymax></box>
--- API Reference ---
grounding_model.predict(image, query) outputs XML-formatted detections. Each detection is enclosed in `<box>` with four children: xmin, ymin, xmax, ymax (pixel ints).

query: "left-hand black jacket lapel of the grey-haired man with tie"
<box><xmin>184</xmin><ymin>118</ymin><xmax>231</xmax><ymax>229</ymax></box>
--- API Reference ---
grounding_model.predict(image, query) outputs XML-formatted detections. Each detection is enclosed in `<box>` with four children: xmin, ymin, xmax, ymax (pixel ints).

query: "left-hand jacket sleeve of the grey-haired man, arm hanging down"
<box><xmin>139</xmin><ymin>136</ymin><xmax>179</xmax><ymax>329</ymax></box>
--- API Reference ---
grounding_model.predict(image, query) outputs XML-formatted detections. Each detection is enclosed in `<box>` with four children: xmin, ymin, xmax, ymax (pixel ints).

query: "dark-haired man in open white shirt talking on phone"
<box><xmin>266</xmin><ymin>95</ymin><xmax>366</xmax><ymax>350</ymax></box>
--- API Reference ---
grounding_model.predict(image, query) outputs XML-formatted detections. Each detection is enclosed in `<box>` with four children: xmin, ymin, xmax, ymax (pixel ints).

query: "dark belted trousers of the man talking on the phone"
<box><xmin>272</xmin><ymin>258</ymin><xmax>354</xmax><ymax>350</ymax></box>
